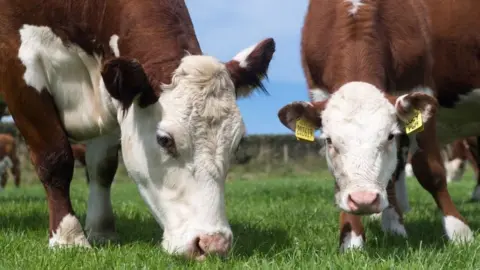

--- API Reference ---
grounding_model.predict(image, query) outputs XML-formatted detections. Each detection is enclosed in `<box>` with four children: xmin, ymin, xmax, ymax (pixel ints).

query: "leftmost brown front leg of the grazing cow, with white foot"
<box><xmin>4</xmin><ymin>86</ymin><xmax>90</xmax><ymax>247</ymax></box>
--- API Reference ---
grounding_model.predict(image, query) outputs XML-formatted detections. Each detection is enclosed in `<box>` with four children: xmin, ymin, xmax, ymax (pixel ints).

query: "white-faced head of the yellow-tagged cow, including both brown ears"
<box><xmin>278</xmin><ymin>82</ymin><xmax>438</xmax><ymax>214</ymax></box>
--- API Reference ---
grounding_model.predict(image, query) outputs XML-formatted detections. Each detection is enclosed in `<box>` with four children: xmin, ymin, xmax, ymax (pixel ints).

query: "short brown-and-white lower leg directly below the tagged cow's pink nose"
<box><xmin>340</xmin><ymin>211</ymin><xmax>366</xmax><ymax>252</ymax></box>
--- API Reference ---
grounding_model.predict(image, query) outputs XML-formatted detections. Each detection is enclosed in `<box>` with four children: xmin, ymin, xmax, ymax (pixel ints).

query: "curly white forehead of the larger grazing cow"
<box><xmin>159</xmin><ymin>55</ymin><xmax>244</xmax><ymax>142</ymax></box>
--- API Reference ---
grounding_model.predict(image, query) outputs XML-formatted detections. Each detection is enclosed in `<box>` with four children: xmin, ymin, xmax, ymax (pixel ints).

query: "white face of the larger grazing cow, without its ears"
<box><xmin>119</xmin><ymin>56</ymin><xmax>245</xmax><ymax>255</ymax></box>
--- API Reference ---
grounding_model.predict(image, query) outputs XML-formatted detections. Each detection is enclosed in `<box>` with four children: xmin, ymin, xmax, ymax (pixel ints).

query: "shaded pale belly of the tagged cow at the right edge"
<box><xmin>437</xmin><ymin>90</ymin><xmax>480</xmax><ymax>144</ymax></box>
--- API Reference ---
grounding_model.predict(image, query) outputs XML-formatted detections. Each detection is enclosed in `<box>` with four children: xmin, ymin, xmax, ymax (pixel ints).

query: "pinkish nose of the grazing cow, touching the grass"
<box><xmin>192</xmin><ymin>233</ymin><xmax>232</xmax><ymax>261</ymax></box>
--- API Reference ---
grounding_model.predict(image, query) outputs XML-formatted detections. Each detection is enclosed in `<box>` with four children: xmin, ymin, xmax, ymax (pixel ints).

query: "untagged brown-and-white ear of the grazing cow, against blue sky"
<box><xmin>226</xmin><ymin>38</ymin><xmax>275</xmax><ymax>97</ymax></box>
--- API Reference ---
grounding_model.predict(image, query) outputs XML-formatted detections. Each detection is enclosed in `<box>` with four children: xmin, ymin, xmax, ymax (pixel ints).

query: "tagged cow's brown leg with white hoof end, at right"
<box><xmin>412</xmin><ymin>132</ymin><xmax>473</xmax><ymax>243</ymax></box>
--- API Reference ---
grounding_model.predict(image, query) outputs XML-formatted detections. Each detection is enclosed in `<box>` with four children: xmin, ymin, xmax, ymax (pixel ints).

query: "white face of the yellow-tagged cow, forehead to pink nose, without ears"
<box><xmin>322</xmin><ymin>82</ymin><xmax>400</xmax><ymax>214</ymax></box>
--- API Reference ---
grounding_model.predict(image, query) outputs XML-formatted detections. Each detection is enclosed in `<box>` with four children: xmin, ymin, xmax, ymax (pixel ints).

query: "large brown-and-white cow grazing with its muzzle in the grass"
<box><xmin>0</xmin><ymin>0</ymin><xmax>275</xmax><ymax>260</ymax></box>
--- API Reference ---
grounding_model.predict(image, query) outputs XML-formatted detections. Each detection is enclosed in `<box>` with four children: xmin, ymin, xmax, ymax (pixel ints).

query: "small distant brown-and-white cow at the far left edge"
<box><xmin>0</xmin><ymin>133</ymin><xmax>21</xmax><ymax>189</ymax></box>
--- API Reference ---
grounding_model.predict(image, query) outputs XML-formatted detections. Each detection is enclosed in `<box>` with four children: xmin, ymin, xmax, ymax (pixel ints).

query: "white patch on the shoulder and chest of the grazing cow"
<box><xmin>18</xmin><ymin>25</ymin><xmax>117</xmax><ymax>140</ymax></box>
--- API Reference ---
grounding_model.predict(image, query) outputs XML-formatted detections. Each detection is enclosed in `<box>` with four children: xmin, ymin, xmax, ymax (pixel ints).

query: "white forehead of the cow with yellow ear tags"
<box><xmin>322</xmin><ymin>82</ymin><xmax>398</xmax><ymax>142</ymax></box>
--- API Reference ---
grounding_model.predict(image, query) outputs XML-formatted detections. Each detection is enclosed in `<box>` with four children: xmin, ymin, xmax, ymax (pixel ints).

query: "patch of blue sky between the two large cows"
<box><xmin>186</xmin><ymin>0</ymin><xmax>308</xmax><ymax>134</ymax></box>
